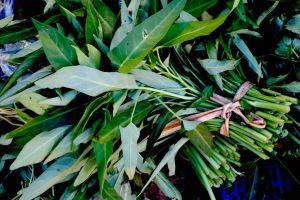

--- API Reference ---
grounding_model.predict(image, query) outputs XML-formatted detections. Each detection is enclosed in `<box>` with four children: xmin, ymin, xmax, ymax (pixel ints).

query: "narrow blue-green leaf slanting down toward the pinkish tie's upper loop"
<box><xmin>233</xmin><ymin>33</ymin><xmax>262</xmax><ymax>77</ymax></box>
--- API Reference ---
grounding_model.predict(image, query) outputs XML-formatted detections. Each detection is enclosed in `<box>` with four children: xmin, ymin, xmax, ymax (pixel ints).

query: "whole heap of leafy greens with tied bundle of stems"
<box><xmin>0</xmin><ymin>0</ymin><xmax>300</xmax><ymax>199</ymax></box>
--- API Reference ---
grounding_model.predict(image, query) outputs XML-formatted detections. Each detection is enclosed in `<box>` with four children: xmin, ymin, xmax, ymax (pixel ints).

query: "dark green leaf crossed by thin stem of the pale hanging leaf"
<box><xmin>99</xmin><ymin>101</ymin><xmax>153</xmax><ymax>143</ymax></box>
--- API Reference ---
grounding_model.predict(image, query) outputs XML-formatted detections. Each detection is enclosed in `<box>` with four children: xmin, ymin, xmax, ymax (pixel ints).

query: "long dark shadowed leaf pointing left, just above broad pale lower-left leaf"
<box><xmin>7</xmin><ymin>105</ymin><xmax>84</xmax><ymax>138</ymax></box>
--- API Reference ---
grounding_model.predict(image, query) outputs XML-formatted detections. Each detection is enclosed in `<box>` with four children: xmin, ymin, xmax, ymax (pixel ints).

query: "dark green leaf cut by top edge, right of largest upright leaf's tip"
<box><xmin>184</xmin><ymin>0</ymin><xmax>218</xmax><ymax>18</ymax></box>
